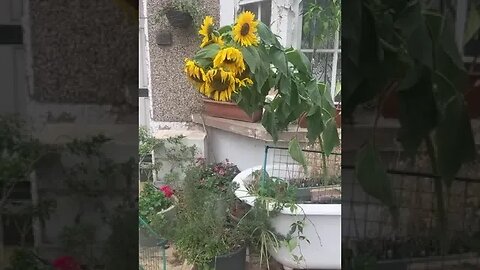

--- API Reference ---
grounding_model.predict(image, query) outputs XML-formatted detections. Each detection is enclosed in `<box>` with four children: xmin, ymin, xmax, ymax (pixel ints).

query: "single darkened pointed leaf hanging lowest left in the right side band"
<box><xmin>355</xmin><ymin>142</ymin><xmax>395</xmax><ymax>210</ymax></box>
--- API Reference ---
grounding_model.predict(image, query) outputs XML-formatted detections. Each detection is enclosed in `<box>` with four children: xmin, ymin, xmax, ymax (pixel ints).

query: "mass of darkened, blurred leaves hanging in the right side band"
<box><xmin>342</xmin><ymin>0</ymin><xmax>476</xmax><ymax>254</ymax></box>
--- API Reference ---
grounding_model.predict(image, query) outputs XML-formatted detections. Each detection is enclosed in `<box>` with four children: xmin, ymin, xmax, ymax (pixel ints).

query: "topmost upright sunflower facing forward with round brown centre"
<box><xmin>233</xmin><ymin>11</ymin><xmax>258</xmax><ymax>47</ymax></box>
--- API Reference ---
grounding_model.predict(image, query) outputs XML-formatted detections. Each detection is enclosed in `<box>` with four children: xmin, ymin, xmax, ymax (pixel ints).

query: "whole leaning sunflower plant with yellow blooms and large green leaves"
<box><xmin>185</xmin><ymin>12</ymin><xmax>339</xmax><ymax>156</ymax></box>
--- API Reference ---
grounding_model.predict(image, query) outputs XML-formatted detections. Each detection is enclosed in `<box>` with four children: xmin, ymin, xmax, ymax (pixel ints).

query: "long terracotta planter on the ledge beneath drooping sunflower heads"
<box><xmin>203</xmin><ymin>99</ymin><xmax>262</xmax><ymax>123</ymax></box>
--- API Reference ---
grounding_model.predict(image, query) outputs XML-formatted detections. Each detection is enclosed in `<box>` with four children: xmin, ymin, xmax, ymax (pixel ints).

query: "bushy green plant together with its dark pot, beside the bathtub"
<box><xmin>174</xmin><ymin>159</ymin><xmax>248</xmax><ymax>270</ymax></box>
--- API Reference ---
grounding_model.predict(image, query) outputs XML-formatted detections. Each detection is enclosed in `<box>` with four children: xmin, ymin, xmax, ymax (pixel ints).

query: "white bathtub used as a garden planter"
<box><xmin>233</xmin><ymin>165</ymin><xmax>342</xmax><ymax>269</ymax></box>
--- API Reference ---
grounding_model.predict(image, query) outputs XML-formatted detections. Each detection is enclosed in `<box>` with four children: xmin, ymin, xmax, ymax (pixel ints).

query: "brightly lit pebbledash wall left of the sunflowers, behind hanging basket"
<box><xmin>147</xmin><ymin>0</ymin><xmax>220</xmax><ymax>122</ymax></box>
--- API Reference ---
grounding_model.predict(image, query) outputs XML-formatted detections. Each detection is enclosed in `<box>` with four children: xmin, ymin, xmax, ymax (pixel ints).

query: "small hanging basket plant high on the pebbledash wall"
<box><xmin>159</xmin><ymin>0</ymin><xmax>202</xmax><ymax>29</ymax></box>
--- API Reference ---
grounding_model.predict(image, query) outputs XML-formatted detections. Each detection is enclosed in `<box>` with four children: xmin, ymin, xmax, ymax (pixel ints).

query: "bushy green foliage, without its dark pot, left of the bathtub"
<box><xmin>174</xmin><ymin>161</ymin><xmax>248</xmax><ymax>269</ymax></box>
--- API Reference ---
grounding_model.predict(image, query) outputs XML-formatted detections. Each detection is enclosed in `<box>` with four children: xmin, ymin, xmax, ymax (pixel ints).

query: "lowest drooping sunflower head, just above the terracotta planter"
<box><xmin>205</xmin><ymin>68</ymin><xmax>238</xmax><ymax>101</ymax></box>
